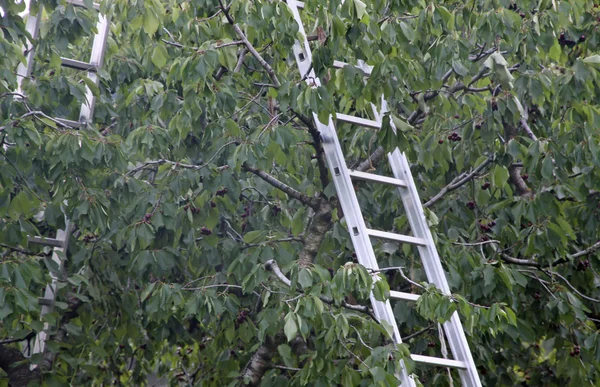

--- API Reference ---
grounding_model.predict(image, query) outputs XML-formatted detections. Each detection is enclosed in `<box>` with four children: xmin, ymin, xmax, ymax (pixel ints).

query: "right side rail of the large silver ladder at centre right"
<box><xmin>388</xmin><ymin>148</ymin><xmax>481</xmax><ymax>387</ymax></box>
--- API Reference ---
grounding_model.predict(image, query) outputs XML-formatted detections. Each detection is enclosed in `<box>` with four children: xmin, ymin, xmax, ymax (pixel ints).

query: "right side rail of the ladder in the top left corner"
<box><xmin>79</xmin><ymin>13</ymin><xmax>110</xmax><ymax>123</ymax></box>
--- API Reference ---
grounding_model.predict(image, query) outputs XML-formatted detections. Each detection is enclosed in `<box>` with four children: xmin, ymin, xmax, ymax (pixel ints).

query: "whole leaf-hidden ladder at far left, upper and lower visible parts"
<box><xmin>17</xmin><ymin>0</ymin><xmax>110</xmax><ymax>358</ymax></box>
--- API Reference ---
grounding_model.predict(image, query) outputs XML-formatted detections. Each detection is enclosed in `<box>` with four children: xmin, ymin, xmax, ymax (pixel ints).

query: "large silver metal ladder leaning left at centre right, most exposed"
<box><xmin>286</xmin><ymin>0</ymin><xmax>481</xmax><ymax>387</ymax></box>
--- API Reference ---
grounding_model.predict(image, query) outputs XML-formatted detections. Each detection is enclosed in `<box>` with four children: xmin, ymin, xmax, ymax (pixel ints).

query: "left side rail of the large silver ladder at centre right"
<box><xmin>287</xmin><ymin>0</ymin><xmax>416</xmax><ymax>387</ymax></box>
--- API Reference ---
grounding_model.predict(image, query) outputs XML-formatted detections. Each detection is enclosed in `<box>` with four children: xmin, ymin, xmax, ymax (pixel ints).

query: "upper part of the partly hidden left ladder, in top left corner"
<box><xmin>17</xmin><ymin>0</ymin><xmax>110</xmax><ymax>128</ymax></box>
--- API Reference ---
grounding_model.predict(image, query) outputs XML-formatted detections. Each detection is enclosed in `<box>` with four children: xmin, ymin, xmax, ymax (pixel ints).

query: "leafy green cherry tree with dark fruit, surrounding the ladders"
<box><xmin>0</xmin><ymin>0</ymin><xmax>600</xmax><ymax>386</ymax></box>
